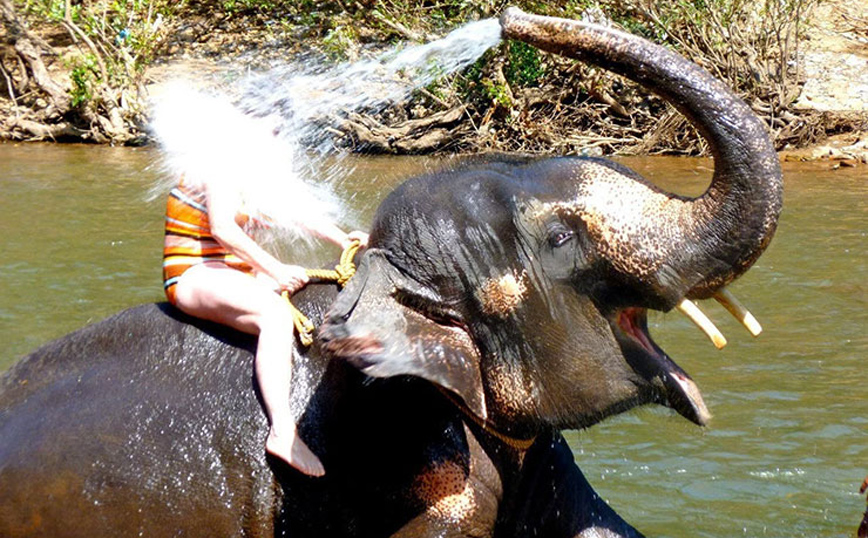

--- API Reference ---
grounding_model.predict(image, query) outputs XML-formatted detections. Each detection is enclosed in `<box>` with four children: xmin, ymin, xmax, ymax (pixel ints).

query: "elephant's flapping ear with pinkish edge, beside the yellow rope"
<box><xmin>318</xmin><ymin>249</ymin><xmax>487</xmax><ymax>419</ymax></box>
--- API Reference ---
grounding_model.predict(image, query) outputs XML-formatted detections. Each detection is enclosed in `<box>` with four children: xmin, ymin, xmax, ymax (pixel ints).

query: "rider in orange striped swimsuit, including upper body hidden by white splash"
<box><xmin>151</xmin><ymin>86</ymin><xmax>368</xmax><ymax>476</ymax></box>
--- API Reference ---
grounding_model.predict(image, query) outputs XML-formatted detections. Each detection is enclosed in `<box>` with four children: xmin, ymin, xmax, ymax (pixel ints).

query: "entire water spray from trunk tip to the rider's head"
<box><xmin>152</xmin><ymin>19</ymin><xmax>500</xmax><ymax>238</ymax></box>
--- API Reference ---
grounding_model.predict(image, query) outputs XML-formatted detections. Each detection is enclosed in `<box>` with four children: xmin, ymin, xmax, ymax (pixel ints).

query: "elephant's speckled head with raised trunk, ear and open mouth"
<box><xmin>321</xmin><ymin>10</ymin><xmax>781</xmax><ymax>435</ymax></box>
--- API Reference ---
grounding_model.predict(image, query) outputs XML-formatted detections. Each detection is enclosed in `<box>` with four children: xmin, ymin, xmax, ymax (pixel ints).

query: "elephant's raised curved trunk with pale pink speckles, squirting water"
<box><xmin>501</xmin><ymin>8</ymin><xmax>782</xmax><ymax>308</ymax></box>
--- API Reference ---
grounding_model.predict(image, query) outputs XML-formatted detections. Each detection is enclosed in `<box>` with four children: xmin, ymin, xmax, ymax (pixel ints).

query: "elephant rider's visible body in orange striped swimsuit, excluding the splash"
<box><xmin>163</xmin><ymin>172</ymin><xmax>368</xmax><ymax>476</ymax></box>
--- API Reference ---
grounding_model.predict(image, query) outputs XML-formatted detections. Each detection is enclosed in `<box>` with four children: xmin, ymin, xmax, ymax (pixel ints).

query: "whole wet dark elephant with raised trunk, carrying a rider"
<box><xmin>0</xmin><ymin>8</ymin><xmax>782</xmax><ymax>538</ymax></box>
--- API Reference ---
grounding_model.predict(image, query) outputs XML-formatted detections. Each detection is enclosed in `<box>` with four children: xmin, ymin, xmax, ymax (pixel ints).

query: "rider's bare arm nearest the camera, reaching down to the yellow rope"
<box><xmin>205</xmin><ymin>180</ymin><xmax>308</xmax><ymax>293</ymax></box>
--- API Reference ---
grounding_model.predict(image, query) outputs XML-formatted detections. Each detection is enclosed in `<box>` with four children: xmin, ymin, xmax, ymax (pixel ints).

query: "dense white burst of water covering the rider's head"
<box><xmin>152</xmin><ymin>85</ymin><xmax>338</xmax><ymax>241</ymax></box>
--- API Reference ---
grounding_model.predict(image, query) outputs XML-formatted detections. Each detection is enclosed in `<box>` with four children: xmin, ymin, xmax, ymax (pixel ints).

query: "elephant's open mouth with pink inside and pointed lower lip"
<box><xmin>612</xmin><ymin>307</ymin><xmax>711</xmax><ymax>426</ymax></box>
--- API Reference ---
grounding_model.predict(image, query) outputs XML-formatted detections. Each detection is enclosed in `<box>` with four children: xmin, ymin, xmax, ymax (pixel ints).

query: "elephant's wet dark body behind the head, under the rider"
<box><xmin>0</xmin><ymin>294</ymin><xmax>635</xmax><ymax>538</ymax></box>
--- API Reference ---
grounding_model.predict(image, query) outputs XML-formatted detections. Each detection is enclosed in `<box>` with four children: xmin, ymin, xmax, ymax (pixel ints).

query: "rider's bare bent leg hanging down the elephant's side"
<box><xmin>175</xmin><ymin>264</ymin><xmax>325</xmax><ymax>476</ymax></box>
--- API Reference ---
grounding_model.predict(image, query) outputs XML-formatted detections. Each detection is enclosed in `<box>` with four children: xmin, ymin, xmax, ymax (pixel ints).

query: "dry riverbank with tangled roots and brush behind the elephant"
<box><xmin>0</xmin><ymin>0</ymin><xmax>868</xmax><ymax>161</ymax></box>
